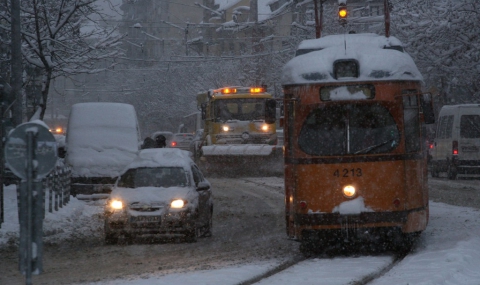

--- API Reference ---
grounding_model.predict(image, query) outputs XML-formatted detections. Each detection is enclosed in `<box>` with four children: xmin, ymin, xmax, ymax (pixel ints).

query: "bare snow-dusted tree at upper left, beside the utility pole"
<box><xmin>0</xmin><ymin>0</ymin><xmax>121</xmax><ymax>119</ymax></box>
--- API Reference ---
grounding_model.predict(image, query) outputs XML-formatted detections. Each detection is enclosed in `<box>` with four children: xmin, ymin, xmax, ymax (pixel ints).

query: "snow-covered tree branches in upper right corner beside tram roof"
<box><xmin>391</xmin><ymin>0</ymin><xmax>480</xmax><ymax>100</ymax></box>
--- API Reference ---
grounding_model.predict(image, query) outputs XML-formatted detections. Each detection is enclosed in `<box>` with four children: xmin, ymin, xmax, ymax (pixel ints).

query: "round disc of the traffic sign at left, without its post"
<box><xmin>5</xmin><ymin>122</ymin><xmax>57</xmax><ymax>179</ymax></box>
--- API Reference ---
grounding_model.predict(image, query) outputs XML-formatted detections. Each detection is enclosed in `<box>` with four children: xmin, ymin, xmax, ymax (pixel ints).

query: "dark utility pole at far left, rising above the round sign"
<box><xmin>10</xmin><ymin>0</ymin><xmax>23</xmax><ymax>126</ymax></box>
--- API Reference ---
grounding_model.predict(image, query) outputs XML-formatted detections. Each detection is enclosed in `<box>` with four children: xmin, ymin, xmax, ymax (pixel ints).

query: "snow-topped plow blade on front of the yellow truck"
<box><xmin>199</xmin><ymin>145</ymin><xmax>283</xmax><ymax>177</ymax></box>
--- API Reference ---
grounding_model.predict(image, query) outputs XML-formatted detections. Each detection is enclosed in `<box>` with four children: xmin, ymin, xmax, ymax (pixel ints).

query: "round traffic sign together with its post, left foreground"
<box><xmin>5</xmin><ymin>122</ymin><xmax>57</xmax><ymax>285</ymax></box>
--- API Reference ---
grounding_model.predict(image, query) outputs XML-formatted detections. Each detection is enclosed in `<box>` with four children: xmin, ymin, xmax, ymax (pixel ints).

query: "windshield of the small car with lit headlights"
<box><xmin>118</xmin><ymin>167</ymin><xmax>188</xmax><ymax>188</ymax></box>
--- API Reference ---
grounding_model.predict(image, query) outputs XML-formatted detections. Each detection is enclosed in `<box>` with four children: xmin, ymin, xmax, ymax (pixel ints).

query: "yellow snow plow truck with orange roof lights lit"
<box><xmin>197</xmin><ymin>86</ymin><xmax>283</xmax><ymax>176</ymax></box>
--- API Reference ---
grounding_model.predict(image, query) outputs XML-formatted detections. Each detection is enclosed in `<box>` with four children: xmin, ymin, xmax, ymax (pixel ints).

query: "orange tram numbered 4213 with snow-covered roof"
<box><xmin>282</xmin><ymin>34</ymin><xmax>434</xmax><ymax>252</ymax></box>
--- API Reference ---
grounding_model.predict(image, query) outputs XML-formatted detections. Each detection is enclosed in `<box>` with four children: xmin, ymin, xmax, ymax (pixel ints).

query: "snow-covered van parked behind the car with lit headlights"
<box><xmin>65</xmin><ymin>102</ymin><xmax>141</xmax><ymax>196</ymax></box>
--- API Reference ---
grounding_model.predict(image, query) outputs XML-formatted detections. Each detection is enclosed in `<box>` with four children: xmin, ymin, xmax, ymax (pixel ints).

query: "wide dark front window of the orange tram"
<box><xmin>298</xmin><ymin>103</ymin><xmax>400</xmax><ymax>156</ymax></box>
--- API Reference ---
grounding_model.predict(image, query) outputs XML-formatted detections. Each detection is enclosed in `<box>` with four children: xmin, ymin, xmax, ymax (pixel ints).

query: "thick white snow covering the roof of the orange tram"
<box><xmin>282</xmin><ymin>34</ymin><xmax>423</xmax><ymax>85</ymax></box>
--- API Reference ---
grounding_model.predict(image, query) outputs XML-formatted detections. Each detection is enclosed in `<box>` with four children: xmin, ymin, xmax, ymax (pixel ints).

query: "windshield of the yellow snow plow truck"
<box><xmin>214</xmin><ymin>98</ymin><xmax>266</xmax><ymax>122</ymax></box>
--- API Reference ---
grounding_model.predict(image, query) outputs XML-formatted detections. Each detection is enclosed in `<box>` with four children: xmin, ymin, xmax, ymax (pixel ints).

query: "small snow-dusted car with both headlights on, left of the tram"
<box><xmin>104</xmin><ymin>148</ymin><xmax>213</xmax><ymax>244</ymax></box>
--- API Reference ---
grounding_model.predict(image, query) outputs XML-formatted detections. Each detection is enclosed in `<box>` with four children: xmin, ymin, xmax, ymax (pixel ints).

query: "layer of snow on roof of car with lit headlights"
<box><xmin>127</xmin><ymin>148</ymin><xmax>193</xmax><ymax>170</ymax></box>
